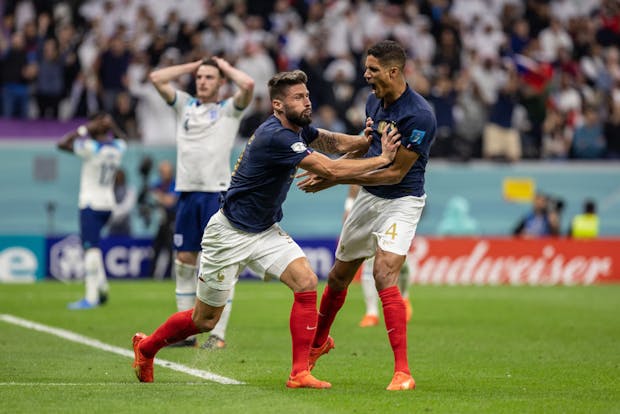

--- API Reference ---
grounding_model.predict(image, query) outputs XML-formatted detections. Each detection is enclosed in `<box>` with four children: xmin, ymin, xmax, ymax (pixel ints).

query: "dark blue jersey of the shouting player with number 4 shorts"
<box><xmin>364</xmin><ymin>87</ymin><xmax>437</xmax><ymax>199</ymax></box>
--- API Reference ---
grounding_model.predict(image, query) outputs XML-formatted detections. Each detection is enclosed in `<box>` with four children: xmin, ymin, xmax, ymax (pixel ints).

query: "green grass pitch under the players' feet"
<box><xmin>0</xmin><ymin>281</ymin><xmax>620</xmax><ymax>414</ymax></box>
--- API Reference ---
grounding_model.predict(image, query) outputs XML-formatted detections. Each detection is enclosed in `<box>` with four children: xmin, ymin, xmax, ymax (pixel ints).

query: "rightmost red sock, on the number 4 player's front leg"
<box><xmin>379</xmin><ymin>286</ymin><xmax>411</xmax><ymax>374</ymax></box>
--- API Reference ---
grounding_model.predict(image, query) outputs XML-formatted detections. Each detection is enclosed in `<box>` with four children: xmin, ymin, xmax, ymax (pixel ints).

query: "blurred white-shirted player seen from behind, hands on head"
<box><xmin>57</xmin><ymin>113</ymin><xmax>127</xmax><ymax>310</ymax></box>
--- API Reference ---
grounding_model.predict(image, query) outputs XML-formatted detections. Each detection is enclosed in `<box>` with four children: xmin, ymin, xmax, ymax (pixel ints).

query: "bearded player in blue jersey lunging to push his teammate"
<box><xmin>133</xmin><ymin>70</ymin><xmax>400</xmax><ymax>388</ymax></box>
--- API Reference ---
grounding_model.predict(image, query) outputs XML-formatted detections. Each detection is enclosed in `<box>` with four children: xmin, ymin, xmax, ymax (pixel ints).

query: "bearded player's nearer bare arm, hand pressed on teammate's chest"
<box><xmin>299</xmin><ymin>124</ymin><xmax>400</xmax><ymax>181</ymax></box>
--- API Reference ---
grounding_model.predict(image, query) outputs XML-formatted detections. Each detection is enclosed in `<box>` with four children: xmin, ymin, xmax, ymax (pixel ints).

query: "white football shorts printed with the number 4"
<box><xmin>336</xmin><ymin>188</ymin><xmax>426</xmax><ymax>262</ymax></box>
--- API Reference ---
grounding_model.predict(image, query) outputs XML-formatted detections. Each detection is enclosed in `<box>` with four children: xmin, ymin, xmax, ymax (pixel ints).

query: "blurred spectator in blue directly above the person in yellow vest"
<box><xmin>571</xmin><ymin>106</ymin><xmax>605</xmax><ymax>159</ymax></box>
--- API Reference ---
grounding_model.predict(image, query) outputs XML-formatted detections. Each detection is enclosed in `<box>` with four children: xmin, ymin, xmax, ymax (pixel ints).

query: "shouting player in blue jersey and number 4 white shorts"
<box><xmin>298</xmin><ymin>40</ymin><xmax>437</xmax><ymax>390</ymax></box>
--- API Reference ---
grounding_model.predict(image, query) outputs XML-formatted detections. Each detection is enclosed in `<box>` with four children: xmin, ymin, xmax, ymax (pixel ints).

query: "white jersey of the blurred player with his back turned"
<box><xmin>73</xmin><ymin>138</ymin><xmax>127</xmax><ymax>210</ymax></box>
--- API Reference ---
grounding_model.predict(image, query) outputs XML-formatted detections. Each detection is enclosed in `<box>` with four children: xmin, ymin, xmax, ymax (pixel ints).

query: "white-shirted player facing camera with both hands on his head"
<box><xmin>150</xmin><ymin>56</ymin><xmax>254</xmax><ymax>349</ymax></box>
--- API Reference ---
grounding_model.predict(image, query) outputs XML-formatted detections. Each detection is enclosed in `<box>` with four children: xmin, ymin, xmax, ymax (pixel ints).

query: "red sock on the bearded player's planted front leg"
<box><xmin>289</xmin><ymin>291</ymin><xmax>316</xmax><ymax>375</ymax></box>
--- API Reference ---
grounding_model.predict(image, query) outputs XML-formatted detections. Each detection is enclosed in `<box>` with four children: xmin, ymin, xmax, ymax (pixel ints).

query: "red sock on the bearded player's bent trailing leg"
<box><xmin>140</xmin><ymin>309</ymin><xmax>200</xmax><ymax>358</ymax></box>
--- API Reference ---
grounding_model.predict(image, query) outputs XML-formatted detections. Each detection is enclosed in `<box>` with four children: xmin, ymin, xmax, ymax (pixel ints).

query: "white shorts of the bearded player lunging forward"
<box><xmin>196</xmin><ymin>211</ymin><xmax>305</xmax><ymax>306</ymax></box>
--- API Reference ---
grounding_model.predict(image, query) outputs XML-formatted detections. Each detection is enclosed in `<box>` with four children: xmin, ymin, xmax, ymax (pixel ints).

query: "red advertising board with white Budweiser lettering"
<box><xmin>407</xmin><ymin>237</ymin><xmax>620</xmax><ymax>285</ymax></box>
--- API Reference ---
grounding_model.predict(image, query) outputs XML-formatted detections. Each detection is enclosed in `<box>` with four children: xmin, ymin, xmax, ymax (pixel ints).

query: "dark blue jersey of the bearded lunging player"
<box><xmin>221</xmin><ymin>115</ymin><xmax>318</xmax><ymax>233</ymax></box>
